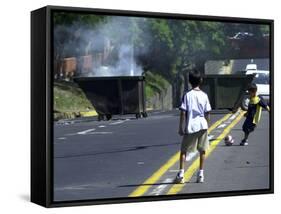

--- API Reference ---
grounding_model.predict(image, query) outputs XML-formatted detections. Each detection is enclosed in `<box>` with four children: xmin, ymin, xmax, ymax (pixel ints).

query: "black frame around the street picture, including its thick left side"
<box><xmin>31</xmin><ymin>6</ymin><xmax>274</xmax><ymax>207</ymax></box>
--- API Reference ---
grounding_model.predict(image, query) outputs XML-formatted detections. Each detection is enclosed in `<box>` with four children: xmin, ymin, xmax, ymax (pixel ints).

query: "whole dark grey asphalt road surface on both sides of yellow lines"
<box><xmin>54</xmin><ymin>111</ymin><xmax>269</xmax><ymax>201</ymax></box>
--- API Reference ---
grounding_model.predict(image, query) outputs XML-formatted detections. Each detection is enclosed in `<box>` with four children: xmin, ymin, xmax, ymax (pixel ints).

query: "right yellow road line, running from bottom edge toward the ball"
<box><xmin>167</xmin><ymin>111</ymin><xmax>244</xmax><ymax>195</ymax></box>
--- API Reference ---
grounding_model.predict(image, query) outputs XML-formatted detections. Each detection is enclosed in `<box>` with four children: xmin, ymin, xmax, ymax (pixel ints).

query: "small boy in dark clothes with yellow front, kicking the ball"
<box><xmin>240</xmin><ymin>83</ymin><xmax>269</xmax><ymax>146</ymax></box>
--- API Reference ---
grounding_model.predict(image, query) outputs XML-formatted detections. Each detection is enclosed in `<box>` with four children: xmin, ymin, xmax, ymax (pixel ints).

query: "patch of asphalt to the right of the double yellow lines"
<box><xmin>179</xmin><ymin>111</ymin><xmax>269</xmax><ymax>193</ymax></box>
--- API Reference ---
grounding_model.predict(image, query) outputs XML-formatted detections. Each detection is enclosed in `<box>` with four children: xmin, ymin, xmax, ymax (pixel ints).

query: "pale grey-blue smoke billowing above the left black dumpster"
<box><xmin>54</xmin><ymin>16</ymin><xmax>149</xmax><ymax>77</ymax></box>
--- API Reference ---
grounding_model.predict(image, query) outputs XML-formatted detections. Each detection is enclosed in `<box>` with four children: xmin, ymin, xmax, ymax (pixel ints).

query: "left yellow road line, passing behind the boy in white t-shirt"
<box><xmin>129</xmin><ymin>113</ymin><xmax>232</xmax><ymax>197</ymax></box>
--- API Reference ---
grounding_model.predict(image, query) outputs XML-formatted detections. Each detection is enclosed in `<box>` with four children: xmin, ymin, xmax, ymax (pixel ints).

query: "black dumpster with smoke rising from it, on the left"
<box><xmin>74</xmin><ymin>76</ymin><xmax>147</xmax><ymax>120</ymax></box>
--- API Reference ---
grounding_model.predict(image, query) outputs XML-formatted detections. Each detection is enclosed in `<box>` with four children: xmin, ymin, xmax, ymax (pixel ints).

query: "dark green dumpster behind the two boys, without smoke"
<box><xmin>201</xmin><ymin>74</ymin><xmax>255</xmax><ymax>111</ymax></box>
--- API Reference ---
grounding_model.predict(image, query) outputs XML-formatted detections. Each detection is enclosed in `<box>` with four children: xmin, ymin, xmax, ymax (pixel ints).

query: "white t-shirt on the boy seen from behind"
<box><xmin>180</xmin><ymin>88</ymin><xmax>211</xmax><ymax>133</ymax></box>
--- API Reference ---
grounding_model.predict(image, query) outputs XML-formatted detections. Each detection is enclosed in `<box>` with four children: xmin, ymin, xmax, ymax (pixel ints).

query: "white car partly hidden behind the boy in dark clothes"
<box><xmin>242</xmin><ymin>64</ymin><xmax>270</xmax><ymax>110</ymax></box>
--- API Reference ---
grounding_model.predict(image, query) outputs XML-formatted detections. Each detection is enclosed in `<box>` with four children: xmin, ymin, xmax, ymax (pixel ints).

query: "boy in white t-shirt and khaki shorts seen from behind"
<box><xmin>176</xmin><ymin>71</ymin><xmax>211</xmax><ymax>183</ymax></box>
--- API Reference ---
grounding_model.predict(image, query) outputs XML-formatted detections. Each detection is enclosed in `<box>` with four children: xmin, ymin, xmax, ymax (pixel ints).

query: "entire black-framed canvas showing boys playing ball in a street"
<box><xmin>31</xmin><ymin>6</ymin><xmax>274</xmax><ymax>207</ymax></box>
